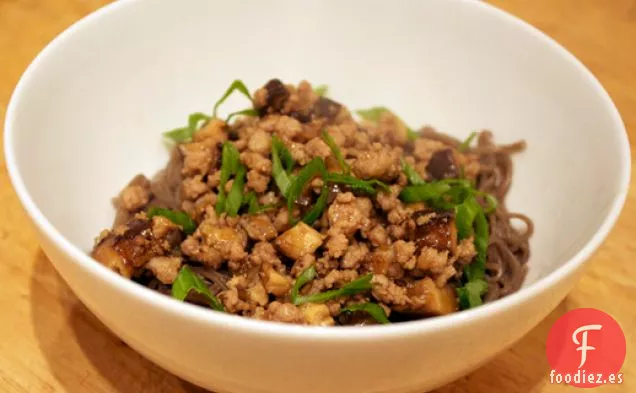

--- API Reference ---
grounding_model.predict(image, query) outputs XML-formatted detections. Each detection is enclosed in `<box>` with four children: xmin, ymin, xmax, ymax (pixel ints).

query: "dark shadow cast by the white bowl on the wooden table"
<box><xmin>31</xmin><ymin>250</ymin><xmax>568</xmax><ymax>393</ymax></box>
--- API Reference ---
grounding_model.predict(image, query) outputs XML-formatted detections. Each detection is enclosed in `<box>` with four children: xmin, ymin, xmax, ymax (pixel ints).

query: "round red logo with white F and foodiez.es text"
<box><xmin>546</xmin><ymin>308</ymin><xmax>626</xmax><ymax>388</ymax></box>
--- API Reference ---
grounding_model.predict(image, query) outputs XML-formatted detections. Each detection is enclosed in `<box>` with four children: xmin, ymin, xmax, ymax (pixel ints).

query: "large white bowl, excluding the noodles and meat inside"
<box><xmin>5</xmin><ymin>0</ymin><xmax>630</xmax><ymax>393</ymax></box>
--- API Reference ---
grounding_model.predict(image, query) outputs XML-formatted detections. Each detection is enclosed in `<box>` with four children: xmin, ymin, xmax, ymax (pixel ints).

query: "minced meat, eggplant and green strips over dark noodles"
<box><xmin>92</xmin><ymin>79</ymin><xmax>533</xmax><ymax>326</ymax></box>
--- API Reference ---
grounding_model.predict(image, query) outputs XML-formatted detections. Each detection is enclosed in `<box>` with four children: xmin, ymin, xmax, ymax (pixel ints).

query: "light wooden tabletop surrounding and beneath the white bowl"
<box><xmin>0</xmin><ymin>0</ymin><xmax>636</xmax><ymax>393</ymax></box>
